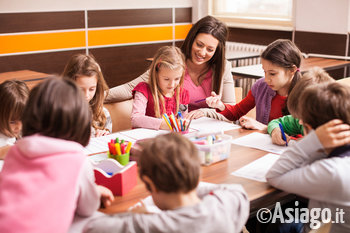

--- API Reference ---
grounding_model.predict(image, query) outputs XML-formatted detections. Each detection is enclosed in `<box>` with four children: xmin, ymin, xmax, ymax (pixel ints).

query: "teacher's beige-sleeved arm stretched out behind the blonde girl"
<box><xmin>105</xmin><ymin>70</ymin><xmax>149</xmax><ymax>103</ymax></box>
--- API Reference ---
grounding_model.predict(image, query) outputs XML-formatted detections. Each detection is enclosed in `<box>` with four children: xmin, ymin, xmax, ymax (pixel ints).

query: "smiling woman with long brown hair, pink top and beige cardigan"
<box><xmin>106</xmin><ymin>16</ymin><xmax>235</xmax><ymax>120</ymax></box>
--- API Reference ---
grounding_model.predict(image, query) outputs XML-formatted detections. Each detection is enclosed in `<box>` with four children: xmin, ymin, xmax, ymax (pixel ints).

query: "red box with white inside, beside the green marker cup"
<box><xmin>93</xmin><ymin>159</ymin><xmax>137</xmax><ymax>196</ymax></box>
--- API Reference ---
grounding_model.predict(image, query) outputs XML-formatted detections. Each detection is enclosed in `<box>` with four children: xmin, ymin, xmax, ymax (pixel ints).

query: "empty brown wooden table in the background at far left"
<box><xmin>0</xmin><ymin>70</ymin><xmax>49</xmax><ymax>89</ymax></box>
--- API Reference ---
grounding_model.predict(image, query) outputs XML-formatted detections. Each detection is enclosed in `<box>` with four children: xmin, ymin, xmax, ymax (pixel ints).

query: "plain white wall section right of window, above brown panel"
<box><xmin>295</xmin><ymin>0</ymin><xmax>350</xmax><ymax>34</ymax></box>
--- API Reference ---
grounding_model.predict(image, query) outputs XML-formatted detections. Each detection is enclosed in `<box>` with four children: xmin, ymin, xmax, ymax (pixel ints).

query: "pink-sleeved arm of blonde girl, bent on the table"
<box><xmin>131</xmin><ymin>91</ymin><xmax>168</xmax><ymax>130</ymax></box>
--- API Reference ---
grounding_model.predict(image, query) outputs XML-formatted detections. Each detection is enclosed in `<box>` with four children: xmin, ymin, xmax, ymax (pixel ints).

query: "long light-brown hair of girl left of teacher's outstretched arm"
<box><xmin>62</xmin><ymin>54</ymin><xmax>108</xmax><ymax>132</ymax></box>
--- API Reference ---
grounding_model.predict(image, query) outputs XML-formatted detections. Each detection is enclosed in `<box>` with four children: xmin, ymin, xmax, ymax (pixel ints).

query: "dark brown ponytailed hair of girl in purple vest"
<box><xmin>261</xmin><ymin>39</ymin><xmax>302</xmax><ymax>115</ymax></box>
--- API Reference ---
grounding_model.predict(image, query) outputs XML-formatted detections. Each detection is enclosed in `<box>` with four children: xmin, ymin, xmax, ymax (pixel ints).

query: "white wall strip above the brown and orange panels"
<box><xmin>0</xmin><ymin>0</ymin><xmax>192</xmax><ymax>12</ymax></box>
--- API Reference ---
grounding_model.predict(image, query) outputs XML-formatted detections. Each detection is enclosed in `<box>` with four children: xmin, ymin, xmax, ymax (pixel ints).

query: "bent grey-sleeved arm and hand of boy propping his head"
<box><xmin>266</xmin><ymin>120</ymin><xmax>350</xmax><ymax>201</ymax></box>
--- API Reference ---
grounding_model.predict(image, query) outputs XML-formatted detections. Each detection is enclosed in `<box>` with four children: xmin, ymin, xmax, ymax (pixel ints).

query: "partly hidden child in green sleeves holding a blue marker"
<box><xmin>267</xmin><ymin>67</ymin><xmax>334</xmax><ymax>145</ymax></box>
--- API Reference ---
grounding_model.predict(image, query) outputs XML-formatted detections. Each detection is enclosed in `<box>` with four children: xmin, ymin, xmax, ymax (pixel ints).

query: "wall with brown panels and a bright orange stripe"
<box><xmin>0</xmin><ymin>0</ymin><xmax>192</xmax><ymax>87</ymax></box>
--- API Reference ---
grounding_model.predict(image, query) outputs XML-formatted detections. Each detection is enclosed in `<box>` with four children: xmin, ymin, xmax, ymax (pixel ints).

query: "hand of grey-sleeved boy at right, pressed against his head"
<box><xmin>315</xmin><ymin>119</ymin><xmax>350</xmax><ymax>148</ymax></box>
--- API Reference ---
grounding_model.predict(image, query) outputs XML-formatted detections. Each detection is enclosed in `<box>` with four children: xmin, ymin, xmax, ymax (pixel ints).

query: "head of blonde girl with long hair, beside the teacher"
<box><xmin>149</xmin><ymin>46</ymin><xmax>185</xmax><ymax>117</ymax></box>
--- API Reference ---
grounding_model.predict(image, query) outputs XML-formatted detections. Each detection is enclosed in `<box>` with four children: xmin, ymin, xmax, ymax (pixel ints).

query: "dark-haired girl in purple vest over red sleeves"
<box><xmin>206</xmin><ymin>39</ymin><xmax>302</xmax><ymax>132</ymax></box>
